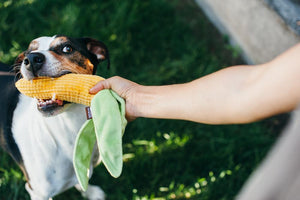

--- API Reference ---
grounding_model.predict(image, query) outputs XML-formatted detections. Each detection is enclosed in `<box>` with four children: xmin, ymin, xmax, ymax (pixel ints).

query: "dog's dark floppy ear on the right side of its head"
<box><xmin>84</xmin><ymin>38</ymin><xmax>110</xmax><ymax>72</ymax></box>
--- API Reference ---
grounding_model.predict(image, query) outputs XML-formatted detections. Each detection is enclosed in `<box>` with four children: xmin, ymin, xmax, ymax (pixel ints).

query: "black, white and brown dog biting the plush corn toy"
<box><xmin>0</xmin><ymin>36</ymin><xmax>109</xmax><ymax>200</ymax></box>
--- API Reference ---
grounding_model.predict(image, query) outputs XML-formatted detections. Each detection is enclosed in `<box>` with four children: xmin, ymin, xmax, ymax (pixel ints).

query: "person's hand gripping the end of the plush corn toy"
<box><xmin>90</xmin><ymin>76</ymin><xmax>140</xmax><ymax>121</ymax></box>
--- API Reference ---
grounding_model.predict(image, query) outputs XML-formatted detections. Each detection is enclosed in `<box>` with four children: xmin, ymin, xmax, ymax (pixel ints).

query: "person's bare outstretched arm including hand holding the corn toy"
<box><xmin>91</xmin><ymin>44</ymin><xmax>300</xmax><ymax>124</ymax></box>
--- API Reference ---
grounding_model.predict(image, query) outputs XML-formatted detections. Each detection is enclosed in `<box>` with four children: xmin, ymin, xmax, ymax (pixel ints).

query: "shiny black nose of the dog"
<box><xmin>23</xmin><ymin>53</ymin><xmax>45</xmax><ymax>76</ymax></box>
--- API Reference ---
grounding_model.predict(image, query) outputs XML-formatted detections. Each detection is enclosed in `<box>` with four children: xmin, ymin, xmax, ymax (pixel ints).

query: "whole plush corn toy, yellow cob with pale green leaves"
<box><xmin>16</xmin><ymin>74</ymin><xmax>127</xmax><ymax>190</ymax></box>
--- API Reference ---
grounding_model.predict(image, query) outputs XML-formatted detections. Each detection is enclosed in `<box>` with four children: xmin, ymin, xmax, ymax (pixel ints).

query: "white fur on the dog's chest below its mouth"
<box><xmin>12</xmin><ymin>95</ymin><xmax>86</xmax><ymax>196</ymax></box>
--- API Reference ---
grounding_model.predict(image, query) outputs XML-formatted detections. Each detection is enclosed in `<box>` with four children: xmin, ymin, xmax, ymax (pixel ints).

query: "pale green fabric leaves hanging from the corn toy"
<box><xmin>73</xmin><ymin>90</ymin><xmax>127</xmax><ymax>190</ymax></box>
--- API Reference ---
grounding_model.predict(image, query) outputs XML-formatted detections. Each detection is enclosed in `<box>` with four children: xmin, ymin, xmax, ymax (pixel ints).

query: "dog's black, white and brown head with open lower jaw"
<box><xmin>15</xmin><ymin>36</ymin><xmax>109</xmax><ymax>116</ymax></box>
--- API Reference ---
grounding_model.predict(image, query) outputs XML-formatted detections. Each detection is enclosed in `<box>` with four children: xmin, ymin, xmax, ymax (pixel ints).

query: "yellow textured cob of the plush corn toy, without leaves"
<box><xmin>16</xmin><ymin>74</ymin><xmax>104</xmax><ymax>106</ymax></box>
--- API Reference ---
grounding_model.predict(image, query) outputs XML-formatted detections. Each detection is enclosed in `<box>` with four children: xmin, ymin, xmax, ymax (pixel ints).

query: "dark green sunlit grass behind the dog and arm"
<box><xmin>0</xmin><ymin>0</ymin><xmax>286</xmax><ymax>200</ymax></box>
